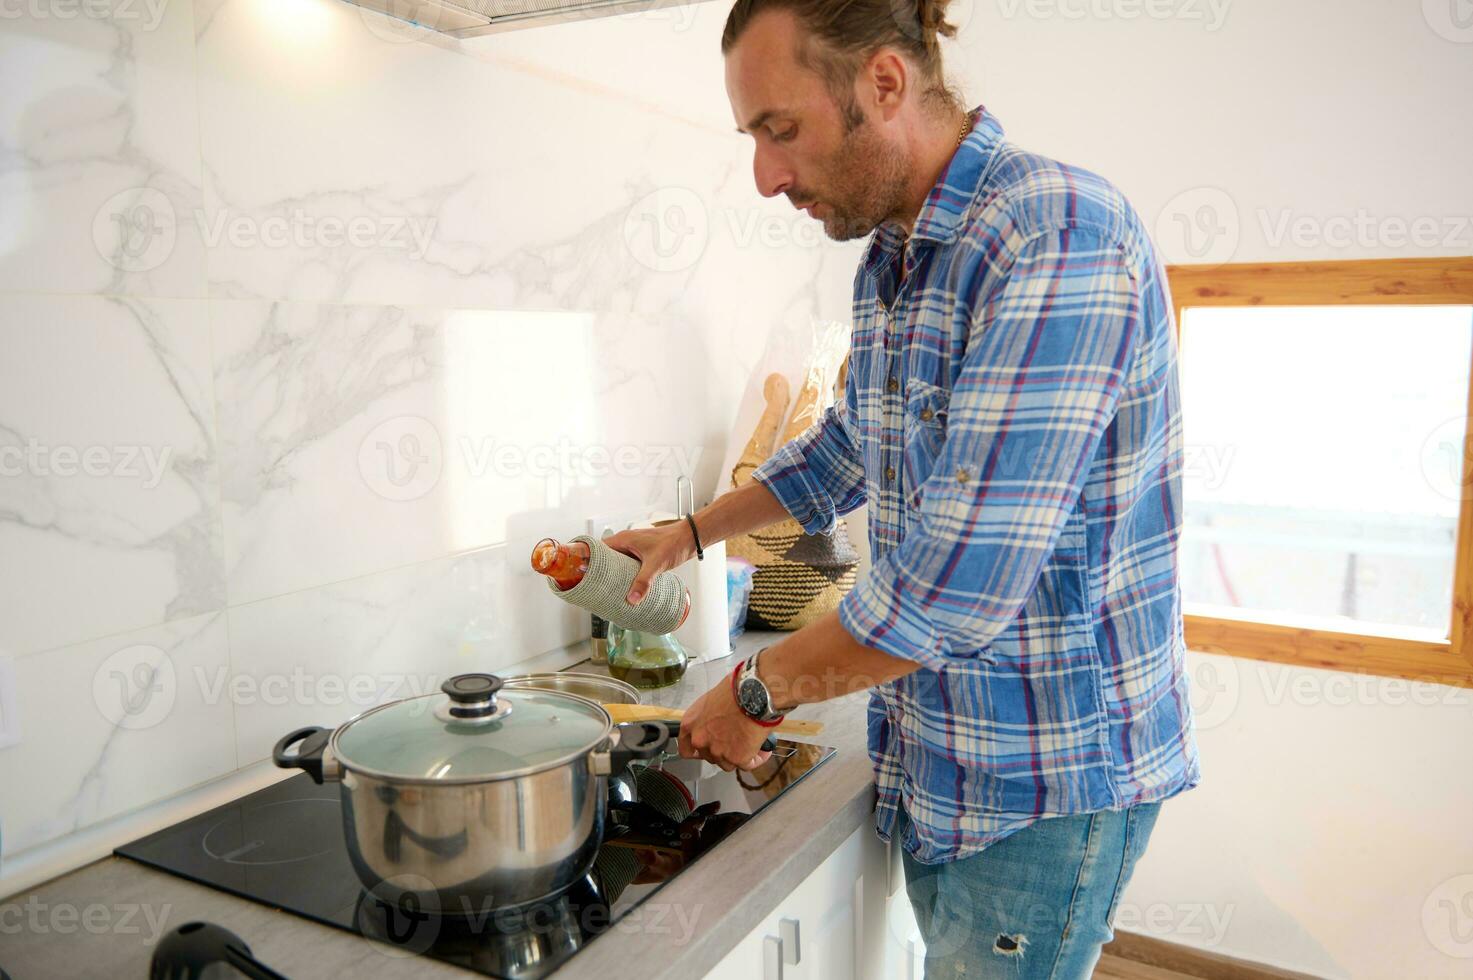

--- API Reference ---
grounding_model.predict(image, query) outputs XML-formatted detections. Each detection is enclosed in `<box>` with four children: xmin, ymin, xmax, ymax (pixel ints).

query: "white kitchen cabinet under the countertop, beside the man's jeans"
<box><xmin>706</xmin><ymin>821</ymin><xmax>888</xmax><ymax>980</ymax></box>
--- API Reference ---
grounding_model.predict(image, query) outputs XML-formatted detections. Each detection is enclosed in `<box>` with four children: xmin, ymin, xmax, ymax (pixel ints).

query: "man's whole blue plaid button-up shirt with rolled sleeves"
<box><xmin>756</xmin><ymin>112</ymin><xmax>1198</xmax><ymax>864</ymax></box>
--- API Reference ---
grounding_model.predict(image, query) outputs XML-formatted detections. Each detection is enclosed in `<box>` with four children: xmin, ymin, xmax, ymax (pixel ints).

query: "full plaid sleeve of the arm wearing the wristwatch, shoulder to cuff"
<box><xmin>840</xmin><ymin>230</ymin><xmax>1143</xmax><ymax>671</ymax></box>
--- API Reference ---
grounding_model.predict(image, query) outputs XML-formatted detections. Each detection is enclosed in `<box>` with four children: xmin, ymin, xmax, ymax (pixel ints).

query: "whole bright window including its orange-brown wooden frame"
<box><xmin>1168</xmin><ymin>259</ymin><xmax>1473</xmax><ymax>685</ymax></box>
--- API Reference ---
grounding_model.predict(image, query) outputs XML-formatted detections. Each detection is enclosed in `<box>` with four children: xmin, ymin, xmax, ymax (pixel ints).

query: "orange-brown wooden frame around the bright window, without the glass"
<box><xmin>1167</xmin><ymin>258</ymin><xmax>1473</xmax><ymax>687</ymax></box>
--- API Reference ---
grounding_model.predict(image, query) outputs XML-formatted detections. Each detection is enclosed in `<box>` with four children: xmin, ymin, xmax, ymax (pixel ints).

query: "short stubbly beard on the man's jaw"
<box><xmin>788</xmin><ymin>113</ymin><xmax>910</xmax><ymax>242</ymax></box>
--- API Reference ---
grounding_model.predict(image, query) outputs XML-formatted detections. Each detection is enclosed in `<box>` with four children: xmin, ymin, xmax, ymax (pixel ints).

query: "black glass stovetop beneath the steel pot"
<box><xmin>115</xmin><ymin>740</ymin><xmax>834</xmax><ymax>980</ymax></box>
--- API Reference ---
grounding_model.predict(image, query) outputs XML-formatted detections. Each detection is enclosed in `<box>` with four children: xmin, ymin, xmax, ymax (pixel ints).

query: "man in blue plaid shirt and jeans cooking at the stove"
<box><xmin>610</xmin><ymin>0</ymin><xmax>1198</xmax><ymax>980</ymax></box>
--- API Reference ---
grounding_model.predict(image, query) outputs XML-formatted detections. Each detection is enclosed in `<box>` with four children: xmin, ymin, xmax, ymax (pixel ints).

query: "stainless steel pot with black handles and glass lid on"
<box><xmin>273</xmin><ymin>673</ymin><xmax>672</xmax><ymax>915</ymax></box>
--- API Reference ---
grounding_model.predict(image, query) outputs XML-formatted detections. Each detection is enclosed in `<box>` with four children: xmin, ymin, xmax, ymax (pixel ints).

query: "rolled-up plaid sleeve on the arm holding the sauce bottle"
<box><xmin>751</xmin><ymin>371</ymin><xmax>865</xmax><ymax>535</ymax></box>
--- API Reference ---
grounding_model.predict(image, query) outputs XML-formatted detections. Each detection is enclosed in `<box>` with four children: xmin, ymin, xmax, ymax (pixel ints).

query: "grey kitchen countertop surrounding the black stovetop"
<box><xmin>0</xmin><ymin>632</ymin><xmax>875</xmax><ymax>980</ymax></box>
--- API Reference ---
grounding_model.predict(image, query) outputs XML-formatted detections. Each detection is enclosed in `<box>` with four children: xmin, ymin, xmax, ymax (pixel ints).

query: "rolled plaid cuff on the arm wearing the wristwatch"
<box><xmin>838</xmin><ymin>553</ymin><xmax>952</xmax><ymax>672</ymax></box>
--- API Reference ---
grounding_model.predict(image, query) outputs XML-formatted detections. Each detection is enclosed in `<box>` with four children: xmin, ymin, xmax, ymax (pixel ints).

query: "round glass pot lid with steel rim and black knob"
<box><xmin>333</xmin><ymin>673</ymin><xmax>611</xmax><ymax>783</ymax></box>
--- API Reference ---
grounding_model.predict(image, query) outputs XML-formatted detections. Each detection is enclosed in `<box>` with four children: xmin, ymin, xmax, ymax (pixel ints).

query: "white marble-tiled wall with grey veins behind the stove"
<box><xmin>0</xmin><ymin>0</ymin><xmax>857</xmax><ymax>866</ymax></box>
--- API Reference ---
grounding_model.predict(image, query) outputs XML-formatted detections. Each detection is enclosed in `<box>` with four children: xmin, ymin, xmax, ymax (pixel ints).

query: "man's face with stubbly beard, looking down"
<box><xmin>726</xmin><ymin>10</ymin><xmax>910</xmax><ymax>242</ymax></box>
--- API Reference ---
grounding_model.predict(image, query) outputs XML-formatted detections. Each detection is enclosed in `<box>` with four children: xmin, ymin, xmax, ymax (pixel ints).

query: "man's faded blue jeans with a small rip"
<box><xmin>893</xmin><ymin>803</ymin><xmax>1161</xmax><ymax>980</ymax></box>
